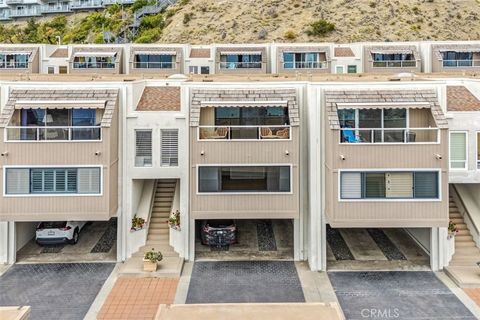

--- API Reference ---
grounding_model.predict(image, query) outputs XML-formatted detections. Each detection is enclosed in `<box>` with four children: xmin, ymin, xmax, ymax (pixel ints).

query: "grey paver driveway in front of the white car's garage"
<box><xmin>0</xmin><ymin>263</ymin><xmax>115</xmax><ymax>320</ymax></box>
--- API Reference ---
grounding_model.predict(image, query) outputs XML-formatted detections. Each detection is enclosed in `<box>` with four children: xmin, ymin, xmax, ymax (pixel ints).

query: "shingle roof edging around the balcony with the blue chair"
<box><xmin>325</xmin><ymin>89</ymin><xmax>448</xmax><ymax>129</ymax></box>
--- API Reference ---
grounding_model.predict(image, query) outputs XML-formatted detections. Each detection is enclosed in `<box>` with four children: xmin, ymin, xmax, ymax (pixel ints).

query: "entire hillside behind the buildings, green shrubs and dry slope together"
<box><xmin>0</xmin><ymin>0</ymin><xmax>480</xmax><ymax>44</ymax></box>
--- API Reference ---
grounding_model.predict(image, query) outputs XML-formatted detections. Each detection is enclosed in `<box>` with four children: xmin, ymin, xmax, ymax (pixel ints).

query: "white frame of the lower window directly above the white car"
<box><xmin>2</xmin><ymin>165</ymin><xmax>104</xmax><ymax>198</ymax></box>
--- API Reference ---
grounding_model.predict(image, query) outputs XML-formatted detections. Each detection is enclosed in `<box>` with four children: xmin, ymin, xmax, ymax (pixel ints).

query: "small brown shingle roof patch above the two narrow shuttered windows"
<box><xmin>136</xmin><ymin>87</ymin><xmax>180</xmax><ymax>111</ymax></box>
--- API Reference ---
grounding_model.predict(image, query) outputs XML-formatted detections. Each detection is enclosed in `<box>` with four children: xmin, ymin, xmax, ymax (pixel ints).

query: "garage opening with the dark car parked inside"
<box><xmin>195</xmin><ymin>219</ymin><xmax>293</xmax><ymax>261</ymax></box>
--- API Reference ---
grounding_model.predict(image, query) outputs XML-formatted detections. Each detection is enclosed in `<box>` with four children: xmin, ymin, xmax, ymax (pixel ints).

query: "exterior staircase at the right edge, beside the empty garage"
<box><xmin>444</xmin><ymin>196</ymin><xmax>480</xmax><ymax>288</ymax></box>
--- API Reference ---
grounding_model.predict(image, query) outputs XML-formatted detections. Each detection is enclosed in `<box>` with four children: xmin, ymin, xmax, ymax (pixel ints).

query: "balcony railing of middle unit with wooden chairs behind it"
<box><xmin>198</xmin><ymin>125</ymin><xmax>291</xmax><ymax>141</ymax></box>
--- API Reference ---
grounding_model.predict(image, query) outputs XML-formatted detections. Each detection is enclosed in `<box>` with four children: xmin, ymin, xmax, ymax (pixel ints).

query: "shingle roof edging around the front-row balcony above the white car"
<box><xmin>0</xmin><ymin>89</ymin><xmax>118</xmax><ymax>127</ymax></box>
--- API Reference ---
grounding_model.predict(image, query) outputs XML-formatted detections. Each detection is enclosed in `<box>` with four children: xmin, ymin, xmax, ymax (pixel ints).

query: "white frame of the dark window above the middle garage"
<box><xmin>195</xmin><ymin>163</ymin><xmax>293</xmax><ymax>196</ymax></box>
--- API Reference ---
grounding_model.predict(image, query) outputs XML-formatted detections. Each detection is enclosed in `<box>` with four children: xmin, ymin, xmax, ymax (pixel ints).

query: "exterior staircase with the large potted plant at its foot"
<box><xmin>120</xmin><ymin>179</ymin><xmax>184</xmax><ymax>277</ymax></box>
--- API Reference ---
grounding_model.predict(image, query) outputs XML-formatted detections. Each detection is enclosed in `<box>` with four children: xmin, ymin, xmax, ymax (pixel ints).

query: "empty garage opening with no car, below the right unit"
<box><xmin>326</xmin><ymin>225</ymin><xmax>430</xmax><ymax>271</ymax></box>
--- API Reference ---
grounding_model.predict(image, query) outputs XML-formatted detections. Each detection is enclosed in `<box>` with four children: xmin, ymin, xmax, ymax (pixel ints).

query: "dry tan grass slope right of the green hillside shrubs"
<box><xmin>160</xmin><ymin>0</ymin><xmax>480</xmax><ymax>43</ymax></box>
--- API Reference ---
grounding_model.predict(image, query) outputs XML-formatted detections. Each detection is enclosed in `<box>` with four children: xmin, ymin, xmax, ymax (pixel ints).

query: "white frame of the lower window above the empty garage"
<box><xmin>337</xmin><ymin>168</ymin><xmax>443</xmax><ymax>202</ymax></box>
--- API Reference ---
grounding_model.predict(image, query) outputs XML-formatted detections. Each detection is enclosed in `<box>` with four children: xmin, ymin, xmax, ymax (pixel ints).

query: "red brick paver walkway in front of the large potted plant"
<box><xmin>97</xmin><ymin>277</ymin><xmax>178</xmax><ymax>320</ymax></box>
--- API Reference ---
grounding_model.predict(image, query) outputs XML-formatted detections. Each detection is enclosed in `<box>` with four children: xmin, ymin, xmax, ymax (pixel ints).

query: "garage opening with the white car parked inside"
<box><xmin>15</xmin><ymin>218</ymin><xmax>117</xmax><ymax>263</ymax></box>
